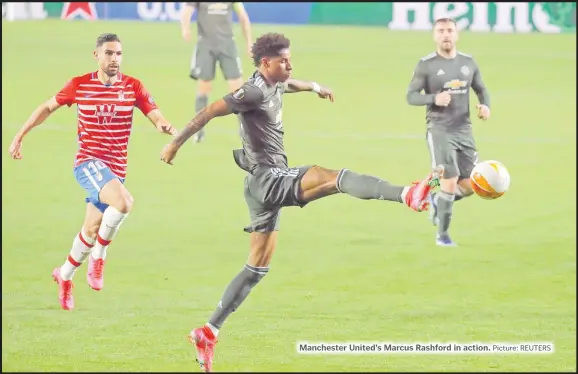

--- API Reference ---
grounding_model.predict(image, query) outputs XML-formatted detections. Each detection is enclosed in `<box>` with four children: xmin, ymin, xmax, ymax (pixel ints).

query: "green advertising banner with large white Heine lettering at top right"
<box><xmin>310</xmin><ymin>2</ymin><xmax>576</xmax><ymax>33</ymax></box>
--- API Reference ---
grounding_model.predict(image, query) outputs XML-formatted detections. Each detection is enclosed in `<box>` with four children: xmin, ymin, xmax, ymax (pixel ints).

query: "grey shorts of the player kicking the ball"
<box><xmin>245</xmin><ymin>166</ymin><xmax>311</xmax><ymax>233</ymax></box>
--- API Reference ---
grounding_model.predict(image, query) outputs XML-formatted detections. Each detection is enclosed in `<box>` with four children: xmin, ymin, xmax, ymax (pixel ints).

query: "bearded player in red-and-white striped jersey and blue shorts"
<box><xmin>9</xmin><ymin>34</ymin><xmax>176</xmax><ymax>310</ymax></box>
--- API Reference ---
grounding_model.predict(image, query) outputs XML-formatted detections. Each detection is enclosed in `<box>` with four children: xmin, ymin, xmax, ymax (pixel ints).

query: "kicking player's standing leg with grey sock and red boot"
<box><xmin>188</xmin><ymin>231</ymin><xmax>277</xmax><ymax>372</ymax></box>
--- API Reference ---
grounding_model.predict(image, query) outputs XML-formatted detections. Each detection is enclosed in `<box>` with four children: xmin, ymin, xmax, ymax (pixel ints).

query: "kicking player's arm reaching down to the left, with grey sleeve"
<box><xmin>161</xmin><ymin>83</ymin><xmax>263</xmax><ymax>164</ymax></box>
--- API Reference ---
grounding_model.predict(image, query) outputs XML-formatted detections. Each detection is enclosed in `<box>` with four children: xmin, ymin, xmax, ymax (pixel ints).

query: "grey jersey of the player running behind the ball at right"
<box><xmin>407</xmin><ymin>52</ymin><xmax>490</xmax><ymax>129</ymax></box>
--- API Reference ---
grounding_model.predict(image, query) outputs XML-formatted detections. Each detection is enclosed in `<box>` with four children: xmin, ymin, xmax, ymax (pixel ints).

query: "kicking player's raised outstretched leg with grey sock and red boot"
<box><xmin>299</xmin><ymin>165</ymin><xmax>444</xmax><ymax>212</ymax></box>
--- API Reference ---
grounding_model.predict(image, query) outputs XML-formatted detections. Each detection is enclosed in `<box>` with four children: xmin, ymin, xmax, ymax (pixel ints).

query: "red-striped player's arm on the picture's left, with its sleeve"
<box><xmin>8</xmin><ymin>80</ymin><xmax>76</xmax><ymax>160</ymax></box>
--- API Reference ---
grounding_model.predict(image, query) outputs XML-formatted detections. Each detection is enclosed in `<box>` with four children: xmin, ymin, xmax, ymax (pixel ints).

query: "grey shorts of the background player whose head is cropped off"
<box><xmin>190</xmin><ymin>39</ymin><xmax>243</xmax><ymax>81</ymax></box>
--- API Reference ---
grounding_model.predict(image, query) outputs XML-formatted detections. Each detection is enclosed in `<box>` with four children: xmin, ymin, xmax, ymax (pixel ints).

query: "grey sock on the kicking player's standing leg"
<box><xmin>209</xmin><ymin>264</ymin><xmax>269</xmax><ymax>329</ymax></box>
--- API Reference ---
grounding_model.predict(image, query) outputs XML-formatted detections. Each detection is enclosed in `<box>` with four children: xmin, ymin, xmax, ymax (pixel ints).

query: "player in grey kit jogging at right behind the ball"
<box><xmin>407</xmin><ymin>18</ymin><xmax>490</xmax><ymax>246</ymax></box>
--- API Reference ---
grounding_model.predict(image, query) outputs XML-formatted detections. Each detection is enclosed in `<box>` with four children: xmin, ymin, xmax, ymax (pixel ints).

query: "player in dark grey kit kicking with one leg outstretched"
<box><xmin>161</xmin><ymin>34</ymin><xmax>443</xmax><ymax>371</ymax></box>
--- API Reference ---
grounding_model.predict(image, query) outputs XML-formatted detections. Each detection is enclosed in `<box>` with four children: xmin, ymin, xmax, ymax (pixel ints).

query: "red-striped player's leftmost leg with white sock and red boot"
<box><xmin>52</xmin><ymin>204</ymin><xmax>102</xmax><ymax>310</ymax></box>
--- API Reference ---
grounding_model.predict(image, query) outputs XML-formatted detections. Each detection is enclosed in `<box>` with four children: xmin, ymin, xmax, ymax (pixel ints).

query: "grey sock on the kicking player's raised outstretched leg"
<box><xmin>337</xmin><ymin>169</ymin><xmax>404</xmax><ymax>203</ymax></box>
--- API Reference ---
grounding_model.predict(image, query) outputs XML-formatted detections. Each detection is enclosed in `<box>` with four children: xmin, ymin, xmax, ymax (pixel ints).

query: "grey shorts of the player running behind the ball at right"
<box><xmin>426</xmin><ymin>129</ymin><xmax>478</xmax><ymax>180</ymax></box>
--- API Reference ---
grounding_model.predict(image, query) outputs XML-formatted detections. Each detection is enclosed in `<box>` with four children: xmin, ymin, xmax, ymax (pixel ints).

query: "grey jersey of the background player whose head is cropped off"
<box><xmin>187</xmin><ymin>3</ymin><xmax>233</xmax><ymax>43</ymax></box>
